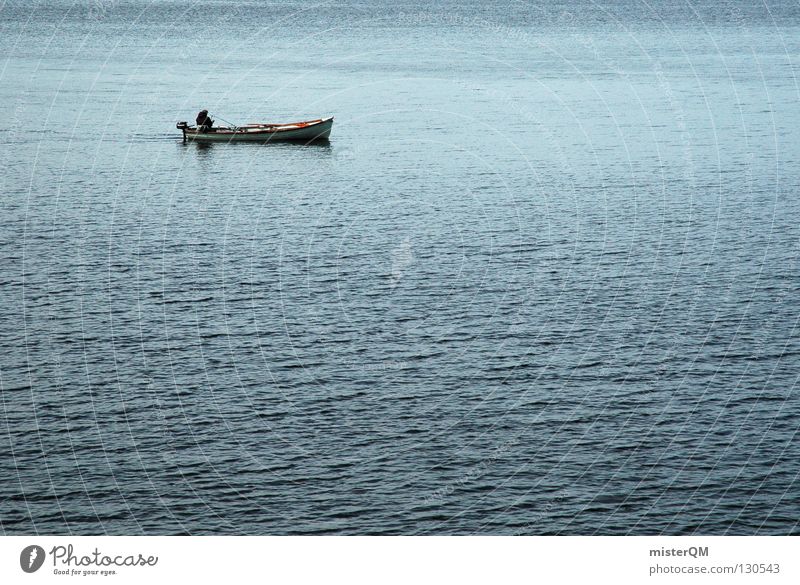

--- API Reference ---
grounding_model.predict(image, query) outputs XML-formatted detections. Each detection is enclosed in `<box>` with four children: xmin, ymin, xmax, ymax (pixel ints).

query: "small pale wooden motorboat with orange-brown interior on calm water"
<box><xmin>176</xmin><ymin>116</ymin><xmax>333</xmax><ymax>142</ymax></box>
